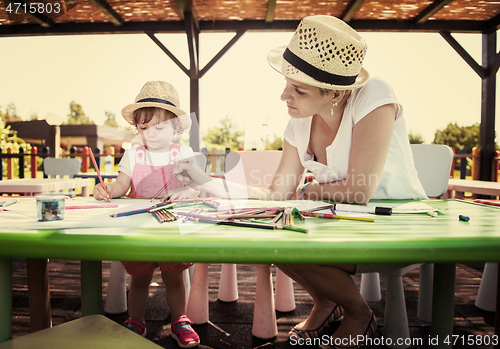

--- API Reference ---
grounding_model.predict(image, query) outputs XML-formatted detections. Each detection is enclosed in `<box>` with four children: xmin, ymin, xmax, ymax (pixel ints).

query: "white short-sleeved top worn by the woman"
<box><xmin>284</xmin><ymin>78</ymin><xmax>427</xmax><ymax>199</ymax></box>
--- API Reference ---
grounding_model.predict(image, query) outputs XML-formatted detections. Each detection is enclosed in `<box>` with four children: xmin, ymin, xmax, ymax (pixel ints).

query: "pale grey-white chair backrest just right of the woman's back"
<box><xmin>411</xmin><ymin>144</ymin><xmax>453</xmax><ymax>197</ymax></box>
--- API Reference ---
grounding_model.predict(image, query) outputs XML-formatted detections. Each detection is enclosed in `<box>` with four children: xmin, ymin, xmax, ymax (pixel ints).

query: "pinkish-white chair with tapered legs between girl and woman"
<box><xmin>188</xmin><ymin>150</ymin><xmax>295</xmax><ymax>339</ymax></box>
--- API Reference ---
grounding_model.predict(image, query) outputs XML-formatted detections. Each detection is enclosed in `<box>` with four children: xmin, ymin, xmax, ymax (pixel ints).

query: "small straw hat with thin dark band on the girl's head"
<box><xmin>122</xmin><ymin>81</ymin><xmax>191</xmax><ymax>125</ymax></box>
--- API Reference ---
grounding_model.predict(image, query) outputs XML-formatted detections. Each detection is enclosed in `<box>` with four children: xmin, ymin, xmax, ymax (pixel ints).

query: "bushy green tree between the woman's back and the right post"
<box><xmin>432</xmin><ymin>123</ymin><xmax>479</xmax><ymax>154</ymax></box>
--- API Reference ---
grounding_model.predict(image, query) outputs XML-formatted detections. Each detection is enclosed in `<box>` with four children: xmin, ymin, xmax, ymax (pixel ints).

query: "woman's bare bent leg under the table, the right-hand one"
<box><xmin>289</xmin><ymin>265</ymin><xmax>371</xmax><ymax>338</ymax></box>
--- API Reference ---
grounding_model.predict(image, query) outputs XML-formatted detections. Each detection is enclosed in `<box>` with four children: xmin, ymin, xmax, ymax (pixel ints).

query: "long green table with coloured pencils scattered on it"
<box><xmin>0</xmin><ymin>200</ymin><xmax>500</xmax><ymax>341</ymax></box>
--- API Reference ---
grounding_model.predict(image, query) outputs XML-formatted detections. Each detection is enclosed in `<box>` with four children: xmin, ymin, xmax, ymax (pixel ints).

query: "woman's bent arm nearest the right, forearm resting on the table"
<box><xmin>304</xmin><ymin>104</ymin><xmax>397</xmax><ymax>204</ymax></box>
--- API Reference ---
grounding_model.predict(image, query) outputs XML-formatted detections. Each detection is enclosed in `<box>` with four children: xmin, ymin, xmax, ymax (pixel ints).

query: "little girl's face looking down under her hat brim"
<box><xmin>137</xmin><ymin>114</ymin><xmax>175</xmax><ymax>153</ymax></box>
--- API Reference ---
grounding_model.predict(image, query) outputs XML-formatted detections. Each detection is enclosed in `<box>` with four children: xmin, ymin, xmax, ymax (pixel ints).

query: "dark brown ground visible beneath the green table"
<box><xmin>13</xmin><ymin>259</ymin><xmax>494</xmax><ymax>349</ymax></box>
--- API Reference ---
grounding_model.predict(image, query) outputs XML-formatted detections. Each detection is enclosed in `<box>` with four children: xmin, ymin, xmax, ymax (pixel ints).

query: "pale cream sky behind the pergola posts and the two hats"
<box><xmin>0</xmin><ymin>27</ymin><xmax>500</xmax><ymax>148</ymax></box>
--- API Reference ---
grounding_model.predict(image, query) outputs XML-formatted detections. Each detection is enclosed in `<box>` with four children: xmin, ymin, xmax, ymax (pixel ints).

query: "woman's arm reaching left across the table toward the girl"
<box><xmin>174</xmin><ymin>141</ymin><xmax>304</xmax><ymax>200</ymax></box>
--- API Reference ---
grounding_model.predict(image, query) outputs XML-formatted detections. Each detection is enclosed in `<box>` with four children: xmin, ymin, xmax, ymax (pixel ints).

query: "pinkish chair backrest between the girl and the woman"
<box><xmin>226</xmin><ymin>150</ymin><xmax>283</xmax><ymax>188</ymax></box>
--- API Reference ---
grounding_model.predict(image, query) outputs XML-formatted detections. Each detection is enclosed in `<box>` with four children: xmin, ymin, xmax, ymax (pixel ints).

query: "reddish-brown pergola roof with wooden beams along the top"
<box><xmin>0</xmin><ymin>0</ymin><xmax>500</xmax><ymax>36</ymax></box>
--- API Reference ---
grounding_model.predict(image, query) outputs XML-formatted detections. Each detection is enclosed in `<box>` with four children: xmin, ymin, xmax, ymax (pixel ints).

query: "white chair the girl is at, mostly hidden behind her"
<box><xmin>104</xmin><ymin>152</ymin><xmax>208</xmax><ymax>314</ymax></box>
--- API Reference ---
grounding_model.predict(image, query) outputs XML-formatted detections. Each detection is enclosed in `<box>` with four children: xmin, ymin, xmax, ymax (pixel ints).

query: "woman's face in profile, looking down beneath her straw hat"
<box><xmin>281</xmin><ymin>78</ymin><xmax>332</xmax><ymax>118</ymax></box>
